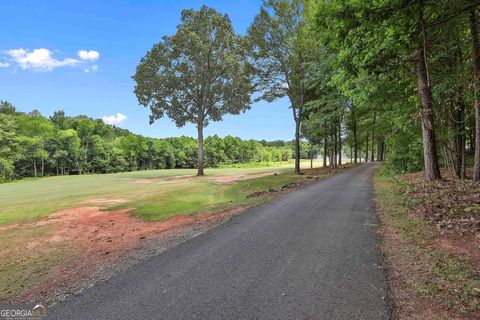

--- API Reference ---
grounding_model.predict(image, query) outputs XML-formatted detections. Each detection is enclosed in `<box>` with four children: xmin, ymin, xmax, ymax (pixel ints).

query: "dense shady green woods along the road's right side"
<box><xmin>304</xmin><ymin>0</ymin><xmax>480</xmax><ymax>180</ymax></box>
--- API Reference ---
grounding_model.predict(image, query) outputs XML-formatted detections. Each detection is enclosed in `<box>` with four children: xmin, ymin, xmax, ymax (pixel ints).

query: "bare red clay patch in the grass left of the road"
<box><xmin>10</xmin><ymin>206</ymin><xmax>246</xmax><ymax>302</ymax></box>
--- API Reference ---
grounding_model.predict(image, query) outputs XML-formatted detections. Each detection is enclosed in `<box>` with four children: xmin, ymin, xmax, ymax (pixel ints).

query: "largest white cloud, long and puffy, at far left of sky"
<box><xmin>4</xmin><ymin>48</ymin><xmax>80</xmax><ymax>71</ymax></box>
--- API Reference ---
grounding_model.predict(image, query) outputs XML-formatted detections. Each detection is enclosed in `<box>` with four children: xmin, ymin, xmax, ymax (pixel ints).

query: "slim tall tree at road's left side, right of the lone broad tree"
<box><xmin>248</xmin><ymin>0</ymin><xmax>311</xmax><ymax>173</ymax></box>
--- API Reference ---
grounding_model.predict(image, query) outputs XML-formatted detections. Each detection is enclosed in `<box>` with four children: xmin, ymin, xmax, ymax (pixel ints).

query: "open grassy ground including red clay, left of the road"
<box><xmin>0</xmin><ymin>161</ymin><xmax>336</xmax><ymax>303</ymax></box>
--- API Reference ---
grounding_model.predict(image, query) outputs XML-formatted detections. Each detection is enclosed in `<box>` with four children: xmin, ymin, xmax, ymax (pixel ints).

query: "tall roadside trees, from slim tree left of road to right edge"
<box><xmin>240</xmin><ymin>0</ymin><xmax>480</xmax><ymax>181</ymax></box>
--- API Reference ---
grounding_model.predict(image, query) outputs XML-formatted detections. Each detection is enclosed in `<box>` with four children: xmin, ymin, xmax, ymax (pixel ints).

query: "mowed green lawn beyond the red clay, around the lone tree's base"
<box><xmin>0</xmin><ymin>162</ymin><xmax>318</xmax><ymax>225</ymax></box>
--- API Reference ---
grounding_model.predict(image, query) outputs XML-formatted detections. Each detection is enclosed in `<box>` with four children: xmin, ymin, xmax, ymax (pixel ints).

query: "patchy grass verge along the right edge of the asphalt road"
<box><xmin>374</xmin><ymin>171</ymin><xmax>480</xmax><ymax>319</ymax></box>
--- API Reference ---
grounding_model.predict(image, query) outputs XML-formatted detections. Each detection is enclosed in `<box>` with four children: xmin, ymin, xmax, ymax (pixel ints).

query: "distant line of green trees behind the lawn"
<box><xmin>0</xmin><ymin>101</ymin><xmax>314</xmax><ymax>181</ymax></box>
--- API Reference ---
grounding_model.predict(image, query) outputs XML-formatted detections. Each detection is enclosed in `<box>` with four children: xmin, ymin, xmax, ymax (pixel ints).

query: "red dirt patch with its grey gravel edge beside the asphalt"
<box><xmin>0</xmin><ymin>206</ymin><xmax>246</xmax><ymax>302</ymax></box>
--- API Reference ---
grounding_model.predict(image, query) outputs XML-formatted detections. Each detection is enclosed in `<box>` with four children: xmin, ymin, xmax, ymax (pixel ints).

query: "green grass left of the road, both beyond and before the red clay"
<box><xmin>0</xmin><ymin>161</ymin><xmax>338</xmax><ymax>301</ymax></box>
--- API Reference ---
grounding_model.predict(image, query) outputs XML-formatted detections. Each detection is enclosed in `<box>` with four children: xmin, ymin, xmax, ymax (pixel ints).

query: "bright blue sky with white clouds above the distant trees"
<box><xmin>0</xmin><ymin>0</ymin><xmax>294</xmax><ymax>140</ymax></box>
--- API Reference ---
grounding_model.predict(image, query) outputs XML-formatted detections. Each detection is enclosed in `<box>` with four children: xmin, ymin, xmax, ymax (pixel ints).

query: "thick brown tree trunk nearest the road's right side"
<box><xmin>416</xmin><ymin>3</ymin><xmax>441</xmax><ymax>180</ymax></box>
